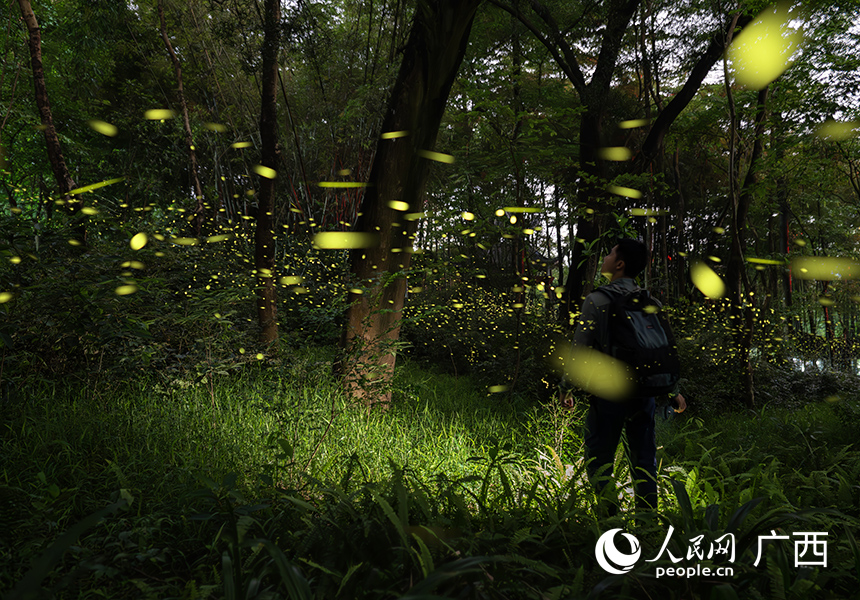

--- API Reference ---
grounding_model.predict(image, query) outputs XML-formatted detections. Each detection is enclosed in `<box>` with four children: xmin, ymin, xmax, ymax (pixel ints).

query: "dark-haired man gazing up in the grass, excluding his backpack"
<box><xmin>573</xmin><ymin>239</ymin><xmax>687</xmax><ymax>514</ymax></box>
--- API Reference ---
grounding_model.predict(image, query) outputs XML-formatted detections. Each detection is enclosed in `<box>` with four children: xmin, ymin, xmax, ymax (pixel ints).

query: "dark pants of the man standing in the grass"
<box><xmin>585</xmin><ymin>396</ymin><xmax>657</xmax><ymax>514</ymax></box>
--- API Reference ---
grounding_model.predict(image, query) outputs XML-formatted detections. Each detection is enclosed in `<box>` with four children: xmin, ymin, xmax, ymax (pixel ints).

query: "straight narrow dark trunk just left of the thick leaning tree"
<box><xmin>254</xmin><ymin>0</ymin><xmax>281</xmax><ymax>344</ymax></box>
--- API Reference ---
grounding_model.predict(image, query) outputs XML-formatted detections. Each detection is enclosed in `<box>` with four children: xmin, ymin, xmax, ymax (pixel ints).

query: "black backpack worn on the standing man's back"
<box><xmin>597</xmin><ymin>288</ymin><xmax>681</xmax><ymax>397</ymax></box>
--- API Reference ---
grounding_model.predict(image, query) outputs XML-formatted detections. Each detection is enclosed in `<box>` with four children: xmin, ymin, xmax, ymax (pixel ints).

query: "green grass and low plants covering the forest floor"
<box><xmin>0</xmin><ymin>348</ymin><xmax>860</xmax><ymax>598</ymax></box>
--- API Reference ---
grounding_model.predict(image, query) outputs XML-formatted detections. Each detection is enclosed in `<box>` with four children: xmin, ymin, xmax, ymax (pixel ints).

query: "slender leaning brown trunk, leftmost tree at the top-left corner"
<box><xmin>18</xmin><ymin>0</ymin><xmax>80</xmax><ymax>206</ymax></box>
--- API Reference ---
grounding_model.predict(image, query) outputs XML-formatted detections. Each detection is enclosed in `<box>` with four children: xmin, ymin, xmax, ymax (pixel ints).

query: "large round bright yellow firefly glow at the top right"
<box><xmin>729</xmin><ymin>5</ymin><xmax>803</xmax><ymax>90</ymax></box>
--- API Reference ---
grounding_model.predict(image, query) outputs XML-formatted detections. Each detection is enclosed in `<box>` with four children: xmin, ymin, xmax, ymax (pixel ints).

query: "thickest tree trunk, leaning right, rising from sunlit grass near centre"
<box><xmin>340</xmin><ymin>0</ymin><xmax>480</xmax><ymax>405</ymax></box>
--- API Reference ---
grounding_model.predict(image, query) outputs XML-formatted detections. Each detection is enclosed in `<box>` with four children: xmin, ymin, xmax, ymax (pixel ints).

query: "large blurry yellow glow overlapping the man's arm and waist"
<box><xmin>552</xmin><ymin>346</ymin><xmax>634</xmax><ymax>401</ymax></box>
